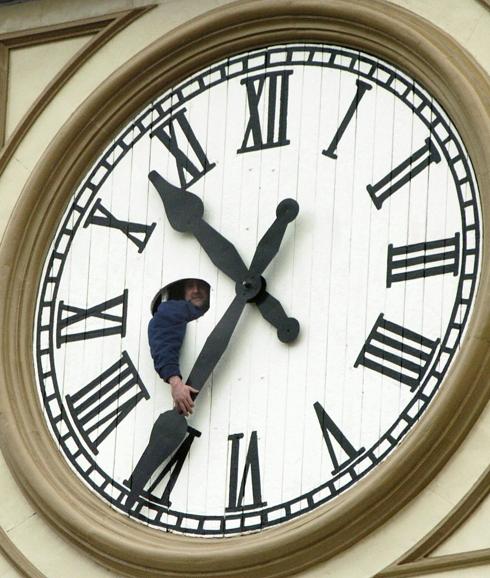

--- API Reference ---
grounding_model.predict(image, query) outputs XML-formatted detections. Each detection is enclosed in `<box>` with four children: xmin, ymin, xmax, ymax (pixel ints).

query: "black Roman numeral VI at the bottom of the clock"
<box><xmin>226</xmin><ymin>431</ymin><xmax>267</xmax><ymax>512</ymax></box>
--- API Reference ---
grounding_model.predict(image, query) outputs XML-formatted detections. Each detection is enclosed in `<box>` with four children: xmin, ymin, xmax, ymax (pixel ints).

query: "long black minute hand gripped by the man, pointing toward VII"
<box><xmin>126</xmin><ymin>292</ymin><xmax>247</xmax><ymax>511</ymax></box>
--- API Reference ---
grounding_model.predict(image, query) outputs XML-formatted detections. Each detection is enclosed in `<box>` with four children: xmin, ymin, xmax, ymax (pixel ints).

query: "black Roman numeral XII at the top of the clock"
<box><xmin>237</xmin><ymin>70</ymin><xmax>293</xmax><ymax>153</ymax></box>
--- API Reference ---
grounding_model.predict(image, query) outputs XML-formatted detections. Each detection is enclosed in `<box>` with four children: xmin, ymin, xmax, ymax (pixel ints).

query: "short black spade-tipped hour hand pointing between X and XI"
<box><xmin>148</xmin><ymin>171</ymin><xmax>248</xmax><ymax>281</ymax></box>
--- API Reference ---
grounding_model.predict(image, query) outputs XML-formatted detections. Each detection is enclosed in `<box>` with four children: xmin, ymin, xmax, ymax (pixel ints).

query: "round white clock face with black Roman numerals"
<box><xmin>34</xmin><ymin>44</ymin><xmax>481</xmax><ymax>536</ymax></box>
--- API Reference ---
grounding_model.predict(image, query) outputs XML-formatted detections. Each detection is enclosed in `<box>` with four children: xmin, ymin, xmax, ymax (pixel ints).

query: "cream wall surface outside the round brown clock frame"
<box><xmin>0</xmin><ymin>0</ymin><xmax>490</xmax><ymax>578</ymax></box>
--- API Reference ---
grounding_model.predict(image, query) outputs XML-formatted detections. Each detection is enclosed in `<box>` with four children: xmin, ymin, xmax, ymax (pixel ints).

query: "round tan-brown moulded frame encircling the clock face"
<box><xmin>0</xmin><ymin>0</ymin><xmax>490</xmax><ymax>576</ymax></box>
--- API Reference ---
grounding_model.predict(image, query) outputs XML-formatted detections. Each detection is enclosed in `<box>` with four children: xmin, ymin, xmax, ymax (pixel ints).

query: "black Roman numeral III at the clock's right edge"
<box><xmin>386</xmin><ymin>233</ymin><xmax>459</xmax><ymax>287</ymax></box>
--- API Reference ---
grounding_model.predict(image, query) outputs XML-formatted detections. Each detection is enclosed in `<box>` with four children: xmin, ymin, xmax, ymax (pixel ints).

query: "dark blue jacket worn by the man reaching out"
<box><xmin>148</xmin><ymin>300</ymin><xmax>205</xmax><ymax>381</ymax></box>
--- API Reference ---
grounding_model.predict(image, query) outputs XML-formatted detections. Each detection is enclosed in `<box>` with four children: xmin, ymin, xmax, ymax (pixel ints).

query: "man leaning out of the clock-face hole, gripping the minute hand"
<box><xmin>148</xmin><ymin>279</ymin><xmax>210</xmax><ymax>416</ymax></box>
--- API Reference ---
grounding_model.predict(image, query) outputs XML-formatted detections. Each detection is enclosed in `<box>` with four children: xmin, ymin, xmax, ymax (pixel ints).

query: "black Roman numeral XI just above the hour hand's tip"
<box><xmin>151</xmin><ymin>108</ymin><xmax>216</xmax><ymax>189</ymax></box>
